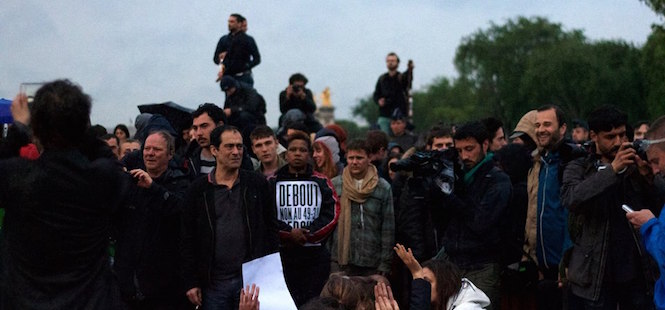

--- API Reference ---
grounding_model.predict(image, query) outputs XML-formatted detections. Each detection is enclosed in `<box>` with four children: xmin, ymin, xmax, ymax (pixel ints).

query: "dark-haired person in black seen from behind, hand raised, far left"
<box><xmin>0</xmin><ymin>81</ymin><xmax>124</xmax><ymax>309</ymax></box>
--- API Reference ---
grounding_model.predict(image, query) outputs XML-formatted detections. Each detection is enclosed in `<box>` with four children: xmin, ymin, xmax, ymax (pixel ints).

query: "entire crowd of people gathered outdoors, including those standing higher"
<box><xmin>0</xmin><ymin>10</ymin><xmax>665</xmax><ymax>310</ymax></box>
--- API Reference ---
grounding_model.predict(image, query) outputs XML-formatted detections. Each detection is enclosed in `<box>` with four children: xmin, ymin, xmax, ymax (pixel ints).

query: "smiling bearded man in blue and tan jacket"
<box><xmin>524</xmin><ymin>105</ymin><xmax>585</xmax><ymax>309</ymax></box>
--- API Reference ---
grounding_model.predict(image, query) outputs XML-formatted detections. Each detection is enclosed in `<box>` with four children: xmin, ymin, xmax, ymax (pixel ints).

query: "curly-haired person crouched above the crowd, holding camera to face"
<box><xmin>279</xmin><ymin>73</ymin><xmax>322</xmax><ymax>133</ymax></box>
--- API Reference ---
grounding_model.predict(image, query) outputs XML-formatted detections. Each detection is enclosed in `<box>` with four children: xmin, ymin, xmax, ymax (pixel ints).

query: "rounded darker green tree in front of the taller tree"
<box><xmin>519</xmin><ymin>40</ymin><xmax>648</xmax><ymax>120</ymax></box>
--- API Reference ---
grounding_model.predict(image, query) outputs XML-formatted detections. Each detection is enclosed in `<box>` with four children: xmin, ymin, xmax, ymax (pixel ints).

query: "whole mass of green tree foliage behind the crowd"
<box><xmin>353</xmin><ymin>14</ymin><xmax>665</xmax><ymax>130</ymax></box>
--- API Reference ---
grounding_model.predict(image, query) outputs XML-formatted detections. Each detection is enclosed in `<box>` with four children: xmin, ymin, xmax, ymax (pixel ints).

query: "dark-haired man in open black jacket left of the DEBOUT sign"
<box><xmin>181</xmin><ymin>126</ymin><xmax>279</xmax><ymax>309</ymax></box>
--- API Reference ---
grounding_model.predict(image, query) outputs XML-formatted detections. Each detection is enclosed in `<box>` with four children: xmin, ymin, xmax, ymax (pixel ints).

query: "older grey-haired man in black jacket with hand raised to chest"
<box><xmin>114</xmin><ymin>131</ymin><xmax>189</xmax><ymax>309</ymax></box>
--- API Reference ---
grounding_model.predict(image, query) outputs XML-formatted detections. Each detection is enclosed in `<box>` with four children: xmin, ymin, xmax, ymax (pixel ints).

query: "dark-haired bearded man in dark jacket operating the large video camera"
<box><xmin>442</xmin><ymin>121</ymin><xmax>512</xmax><ymax>305</ymax></box>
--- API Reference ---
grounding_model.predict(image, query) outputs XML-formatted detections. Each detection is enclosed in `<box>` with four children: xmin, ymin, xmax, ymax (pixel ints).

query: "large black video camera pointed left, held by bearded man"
<box><xmin>390</xmin><ymin>149</ymin><xmax>459</xmax><ymax>195</ymax></box>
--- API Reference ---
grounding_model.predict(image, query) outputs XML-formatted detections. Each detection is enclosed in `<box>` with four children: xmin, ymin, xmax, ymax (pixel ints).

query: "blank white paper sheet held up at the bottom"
<box><xmin>242</xmin><ymin>253</ymin><xmax>297</xmax><ymax>310</ymax></box>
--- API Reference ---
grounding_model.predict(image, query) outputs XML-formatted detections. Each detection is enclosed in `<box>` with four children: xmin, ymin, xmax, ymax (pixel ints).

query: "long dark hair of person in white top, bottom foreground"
<box><xmin>422</xmin><ymin>259</ymin><xmax>462</xmax><ymax>310</ymax></box>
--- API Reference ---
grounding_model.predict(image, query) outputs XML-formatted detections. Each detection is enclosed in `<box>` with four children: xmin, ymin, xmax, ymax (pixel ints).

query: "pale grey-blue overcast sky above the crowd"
<box><xmin>0</xmin><ymin>0</ymin><xmax>662</xmax><ymax>127</ymax></box>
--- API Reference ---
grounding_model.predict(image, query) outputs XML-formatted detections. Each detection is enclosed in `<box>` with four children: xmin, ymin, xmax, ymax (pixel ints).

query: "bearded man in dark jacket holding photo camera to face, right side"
<box><xmin>561</xmin><ymin>106</ymin><xmax>658</xmax><ymax>309</ymax></box>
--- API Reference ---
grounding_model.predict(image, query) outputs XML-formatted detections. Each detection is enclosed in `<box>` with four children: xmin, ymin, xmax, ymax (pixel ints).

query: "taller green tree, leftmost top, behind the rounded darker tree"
<box><xmin>455</xmin><ymin>17</ymin><xmax>585</xmax><ymax>125</ymax></box>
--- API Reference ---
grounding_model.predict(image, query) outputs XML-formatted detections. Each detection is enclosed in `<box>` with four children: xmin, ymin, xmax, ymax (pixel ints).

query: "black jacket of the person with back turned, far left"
<box><xmin>0</xmin><ymin>150</ymin><xmax>120</xmax><ymax>309</ymax></box>
